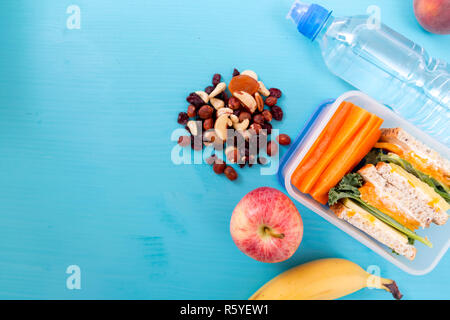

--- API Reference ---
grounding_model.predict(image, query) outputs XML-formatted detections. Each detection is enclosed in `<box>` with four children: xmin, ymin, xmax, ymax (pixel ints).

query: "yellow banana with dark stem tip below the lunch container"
<box><xmin>250</xmin><ymin>259</ymin><xmax>402</xmax><ymax>300</ymax></box>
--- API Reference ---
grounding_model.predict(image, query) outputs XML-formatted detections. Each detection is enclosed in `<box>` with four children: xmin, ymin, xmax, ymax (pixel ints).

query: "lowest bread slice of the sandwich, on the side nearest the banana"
<box><xmin>331</xmin><ymin>199</ymin><xmax>417</xmax><ymax>260</ymax></box>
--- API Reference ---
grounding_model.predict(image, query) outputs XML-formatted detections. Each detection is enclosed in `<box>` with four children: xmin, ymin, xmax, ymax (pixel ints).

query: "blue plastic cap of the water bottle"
<box><xmin>287</xmin><ymin>1</ymin><xmax>332</xmax><ymax>41</ymax></box>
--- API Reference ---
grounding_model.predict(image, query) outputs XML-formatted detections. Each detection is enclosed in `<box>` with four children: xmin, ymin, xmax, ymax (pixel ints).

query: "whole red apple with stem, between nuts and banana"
<box><xmin>230</xmin><ymin>187</ymin><xmax>303</xmax><ymax>262</ymax></box>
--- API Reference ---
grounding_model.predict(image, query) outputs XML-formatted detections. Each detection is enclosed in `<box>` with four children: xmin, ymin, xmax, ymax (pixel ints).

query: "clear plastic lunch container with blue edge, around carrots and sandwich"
<box><xmin>278</xmin><ymin>91</ymin><xmax>450</xmax><ymax>275</ymax></box>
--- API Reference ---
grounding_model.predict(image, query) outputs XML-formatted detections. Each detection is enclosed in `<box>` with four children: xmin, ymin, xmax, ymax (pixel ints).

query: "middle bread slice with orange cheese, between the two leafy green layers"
<box><xmin>358</xmin><ymin>164</ymin><xmax>433</xmax><ymax>231</ymax></box>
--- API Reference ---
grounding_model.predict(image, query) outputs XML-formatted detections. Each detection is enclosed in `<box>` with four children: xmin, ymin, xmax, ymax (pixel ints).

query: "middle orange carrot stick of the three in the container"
<box><xmin>298</xmin><ymin>105</ymin><xmax>371</xmax><ymax>193</ymax></box>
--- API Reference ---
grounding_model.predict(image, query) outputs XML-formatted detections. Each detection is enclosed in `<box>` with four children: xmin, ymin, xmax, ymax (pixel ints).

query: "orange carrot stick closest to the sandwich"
<box><xmin>311</xmin><ymin>114</ymin><xmax>383</xmax><ymax>203</ymax></box>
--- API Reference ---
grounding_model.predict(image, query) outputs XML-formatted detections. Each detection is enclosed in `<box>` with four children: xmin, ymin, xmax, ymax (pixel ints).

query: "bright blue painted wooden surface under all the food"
<box><xmin>0</xmin><ymin>0</ymin><xmax>450</xmax><ymax>299</ymax></box>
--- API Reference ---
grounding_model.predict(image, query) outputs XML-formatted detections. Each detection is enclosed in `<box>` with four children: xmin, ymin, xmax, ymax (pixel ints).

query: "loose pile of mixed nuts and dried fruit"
<box><xmin>178</xmin><ymin>69</ymin><xmax>291</xmax><ymax>180</ymax></box>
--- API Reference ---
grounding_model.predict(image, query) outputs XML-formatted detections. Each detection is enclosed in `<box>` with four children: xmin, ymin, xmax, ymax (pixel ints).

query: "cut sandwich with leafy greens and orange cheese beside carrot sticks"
<box><xmin>328</xmin><ymin>128</ymin><xmax>450</xmax><ymax>260</ymax></box>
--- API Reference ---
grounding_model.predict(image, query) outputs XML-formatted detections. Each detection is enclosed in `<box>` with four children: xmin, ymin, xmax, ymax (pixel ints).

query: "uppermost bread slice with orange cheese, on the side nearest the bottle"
<box><xmin>375</xmin><ymin>128</ymin><xmax>450</xmax><ymax>188</ymax></box>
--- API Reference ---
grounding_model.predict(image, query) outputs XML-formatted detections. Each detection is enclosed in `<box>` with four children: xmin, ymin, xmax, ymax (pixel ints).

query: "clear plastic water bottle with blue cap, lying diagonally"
<box><xmin>288</xmin><ymin>1</ymin><xmax>450</xmax><ymax>146</ymax></box>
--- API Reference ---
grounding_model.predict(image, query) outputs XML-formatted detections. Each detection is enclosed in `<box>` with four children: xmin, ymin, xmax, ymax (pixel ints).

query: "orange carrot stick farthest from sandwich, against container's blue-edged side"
<box><xmin>291</xmin><ymin>101</ymin><xmax>352</xmax><ymax>188</ymax></box>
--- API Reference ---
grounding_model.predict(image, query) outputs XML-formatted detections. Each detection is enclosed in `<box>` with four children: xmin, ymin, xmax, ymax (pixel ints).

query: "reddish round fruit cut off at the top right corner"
<box><xmin>414</xmin><ymin>0</ymin><xmax>450</xmax><ymax>34</ymax></box>
